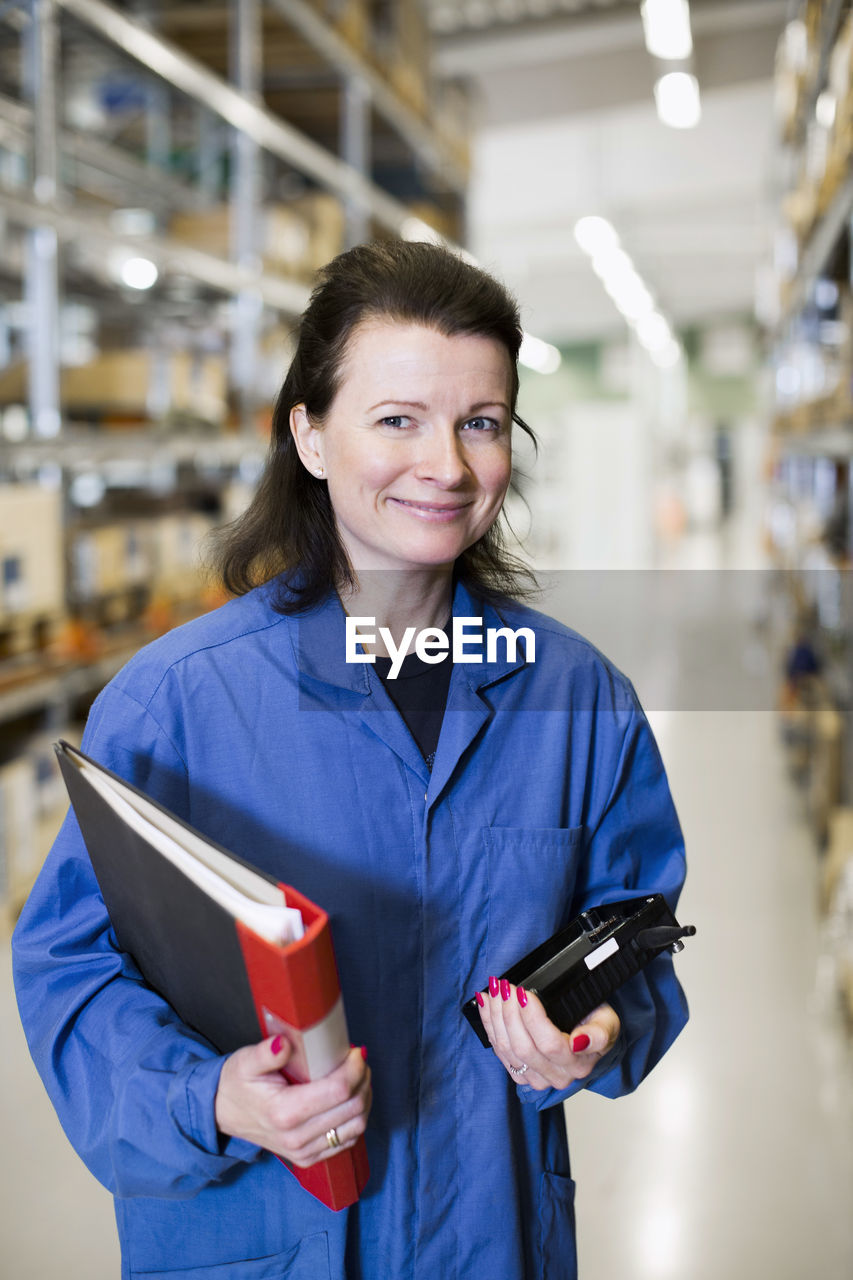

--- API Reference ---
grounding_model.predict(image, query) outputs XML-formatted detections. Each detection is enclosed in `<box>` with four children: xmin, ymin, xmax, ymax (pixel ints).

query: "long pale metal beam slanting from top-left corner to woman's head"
<box><xmin>58</xmin><ymin>0</ymin><xmax>409</xmax><ymax>234</ymax></box>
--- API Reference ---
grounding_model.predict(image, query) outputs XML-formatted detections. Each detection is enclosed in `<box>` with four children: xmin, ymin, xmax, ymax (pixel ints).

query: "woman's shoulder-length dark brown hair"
<box><xmin>208</xmin><ymin>241</ymin><xmax>535</xmax><ymax>613</ymax></box>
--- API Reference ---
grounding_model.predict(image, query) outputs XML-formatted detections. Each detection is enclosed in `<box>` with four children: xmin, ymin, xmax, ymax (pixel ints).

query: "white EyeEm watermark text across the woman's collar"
<box><xmin>346</xmin><ymin>617</ymin><xmax>537</xmax><ymax>680</ymax></box>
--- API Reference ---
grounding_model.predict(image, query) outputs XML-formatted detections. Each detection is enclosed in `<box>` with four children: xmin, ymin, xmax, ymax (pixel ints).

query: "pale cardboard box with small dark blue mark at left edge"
<box><xmin>0</xmin><ymin>485</ymin><xmax>65</xmax><ymax>625</ymax></box>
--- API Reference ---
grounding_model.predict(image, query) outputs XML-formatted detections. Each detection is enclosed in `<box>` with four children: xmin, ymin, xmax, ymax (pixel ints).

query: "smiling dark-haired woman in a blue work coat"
<box><xmin>14</xmin><ymin>243</ymin><xmax>685</xmax><ymax>1280</ymax></box>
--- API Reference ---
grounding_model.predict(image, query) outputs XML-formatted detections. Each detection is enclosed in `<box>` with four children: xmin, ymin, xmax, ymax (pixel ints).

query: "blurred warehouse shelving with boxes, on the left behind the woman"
<box><xmin>0</xmin><ymin>0</ymin><xmax>467</xmax><ymax>921</ymax></box>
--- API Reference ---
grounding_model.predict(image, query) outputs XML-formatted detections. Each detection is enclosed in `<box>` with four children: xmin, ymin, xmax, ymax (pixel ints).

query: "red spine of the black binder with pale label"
<box><xmin>237</xmin><ymin>884</ymin><xmax>370</xmax><ymax>1210</ymax></box>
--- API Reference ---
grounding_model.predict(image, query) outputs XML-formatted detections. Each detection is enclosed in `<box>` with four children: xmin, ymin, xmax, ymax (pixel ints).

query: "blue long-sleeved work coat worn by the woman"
<box><xmin>13</xmin><ymin>585</ymin><xmax>686</xmax><ymax>1280</ymax></box>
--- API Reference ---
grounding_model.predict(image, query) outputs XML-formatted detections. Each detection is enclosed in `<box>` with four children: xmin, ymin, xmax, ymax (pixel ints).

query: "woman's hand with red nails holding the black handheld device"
<box><xmin>478</xmin><ymin>979</ymin><xmax>620</xmax><ymax>1089</ymax></box>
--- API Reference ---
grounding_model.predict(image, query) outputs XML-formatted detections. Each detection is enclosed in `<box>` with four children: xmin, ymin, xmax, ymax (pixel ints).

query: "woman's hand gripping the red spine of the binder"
<box><xmin>215</xmin><ymin>1036</ymin><xmax>373</xmax><ymax>1169</ymax></box>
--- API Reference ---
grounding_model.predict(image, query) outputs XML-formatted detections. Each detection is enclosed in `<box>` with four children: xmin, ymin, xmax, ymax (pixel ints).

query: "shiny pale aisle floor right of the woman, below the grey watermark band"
<box><xmin>567</xmin><ymin>618</ymin><xmax>853</xmax><ymax>1280</ymax></box>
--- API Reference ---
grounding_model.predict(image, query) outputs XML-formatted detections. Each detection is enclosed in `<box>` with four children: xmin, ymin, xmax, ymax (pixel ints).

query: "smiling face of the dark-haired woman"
<box><xmin>291</xmin><ymin>320</ymin><xmax>512</xmax><ymax>570</ymax></box>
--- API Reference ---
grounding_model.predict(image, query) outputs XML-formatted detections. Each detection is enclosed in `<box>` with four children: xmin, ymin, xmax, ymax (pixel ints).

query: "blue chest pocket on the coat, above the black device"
<box><xmin>483</xmin><ymin>827</ymin><xmax>584</xmax><ymax>973</ymax></box>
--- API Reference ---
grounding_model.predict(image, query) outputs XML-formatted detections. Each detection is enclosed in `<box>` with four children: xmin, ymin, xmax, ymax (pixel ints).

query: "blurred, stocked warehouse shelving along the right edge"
<box><xmin>771</xmin><ymin>0</ymin><xmax>853</xmax><ymax>1016</ymax></box>
